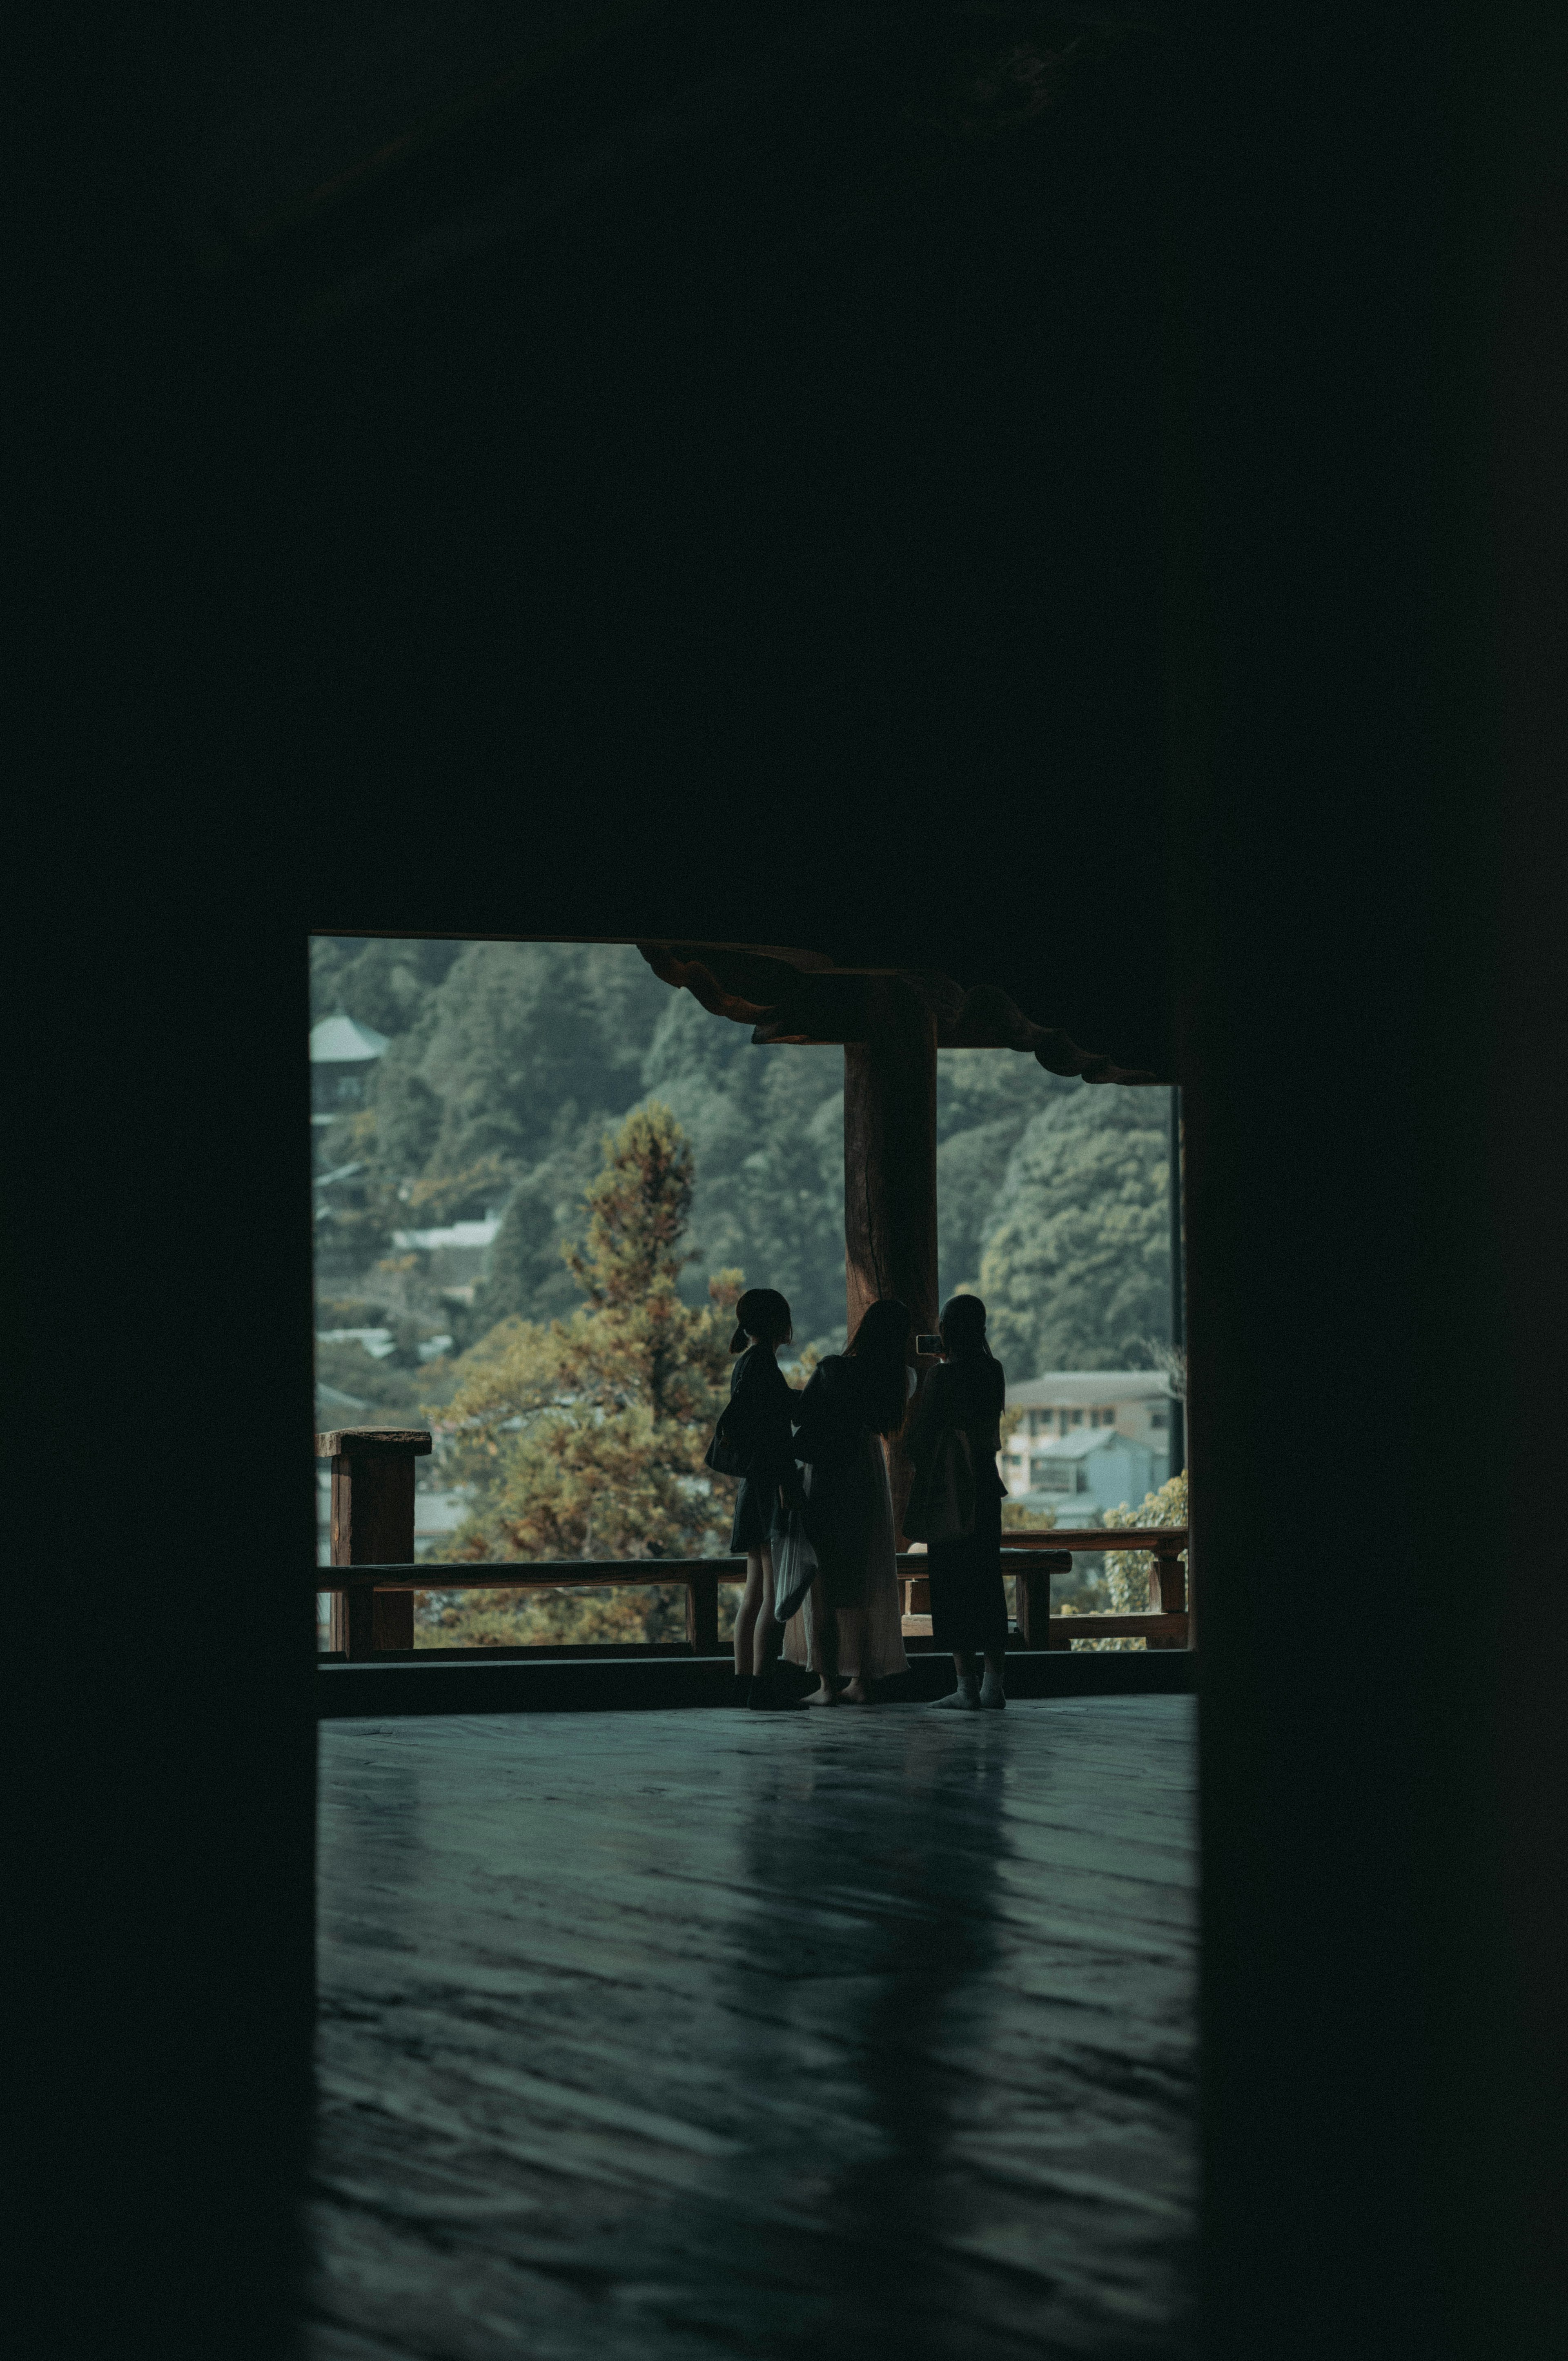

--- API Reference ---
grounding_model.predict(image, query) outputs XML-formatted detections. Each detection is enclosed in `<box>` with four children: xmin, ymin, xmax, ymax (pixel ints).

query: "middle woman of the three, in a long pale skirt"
<box><xmin>784</xmin><ymin>1296</ymin><xmax>914</xmax><ymax>1705</ymax></box>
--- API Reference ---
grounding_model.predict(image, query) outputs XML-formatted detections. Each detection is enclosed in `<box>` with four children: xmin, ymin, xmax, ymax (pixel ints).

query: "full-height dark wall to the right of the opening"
<box><xmin>1171</xmin><ymin>9</ymin><xmax>1568</xmax><ymax>2361</ymax></box>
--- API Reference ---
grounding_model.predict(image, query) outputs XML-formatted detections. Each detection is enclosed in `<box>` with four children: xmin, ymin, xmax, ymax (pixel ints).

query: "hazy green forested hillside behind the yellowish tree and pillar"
<box><xmin>312</xmin><ymin>937</ymin><xmax>1169</xmax><ymax>1377</ymax></box>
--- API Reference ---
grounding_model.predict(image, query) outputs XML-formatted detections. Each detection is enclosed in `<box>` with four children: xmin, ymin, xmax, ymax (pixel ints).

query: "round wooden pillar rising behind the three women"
<box><xmin>843</xmin><ymin>978</ymin><xmax>938</xmax><ymax>1544</ymax></box>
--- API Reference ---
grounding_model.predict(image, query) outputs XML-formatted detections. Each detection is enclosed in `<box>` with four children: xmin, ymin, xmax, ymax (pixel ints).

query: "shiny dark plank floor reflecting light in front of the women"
<box><xmin>307</xmin><ymin>1697</ymin><xmax>1197</xmax><ymax>2361</ymax></box>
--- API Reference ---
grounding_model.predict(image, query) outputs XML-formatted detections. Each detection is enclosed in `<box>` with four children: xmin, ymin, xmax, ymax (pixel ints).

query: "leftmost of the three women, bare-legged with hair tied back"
<box><xmin>725</xmin><ymin>1287</ymin><xmax>800</xmax><ymax>1707</ymax></box>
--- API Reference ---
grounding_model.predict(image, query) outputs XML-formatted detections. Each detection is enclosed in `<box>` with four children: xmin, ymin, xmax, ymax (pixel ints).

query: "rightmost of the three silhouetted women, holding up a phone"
<box><xmin>907</xmin><ymin>1296</ymin><xmax>1008</xmax><ymax>1712</ymax></box>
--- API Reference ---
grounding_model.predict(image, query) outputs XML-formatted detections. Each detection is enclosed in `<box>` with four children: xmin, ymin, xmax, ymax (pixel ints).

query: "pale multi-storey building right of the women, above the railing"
<box><xmin>1001</xmin><ymin>1370</ymin><xmax>1171</xmax><ymax>1525</ymax></box>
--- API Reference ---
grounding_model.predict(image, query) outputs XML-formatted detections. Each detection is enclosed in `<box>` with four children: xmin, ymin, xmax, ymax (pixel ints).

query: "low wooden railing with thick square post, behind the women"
<box><xmin>316</xmin><ymin>1426</ymin><xmax>1190</xmax><ymax>1662</ymax></box>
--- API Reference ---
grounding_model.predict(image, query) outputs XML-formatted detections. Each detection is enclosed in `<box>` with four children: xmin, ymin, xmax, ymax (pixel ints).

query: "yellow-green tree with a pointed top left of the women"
<box><xmin>430</xmin><ymin>1105</ymin><xmax>742</xmax><ymax>1561</ymax></box>
